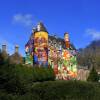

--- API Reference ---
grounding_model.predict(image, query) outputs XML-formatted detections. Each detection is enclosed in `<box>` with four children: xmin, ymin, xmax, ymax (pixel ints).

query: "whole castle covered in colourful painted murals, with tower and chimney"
<box><xmin>25</xmin><ymin>23</ymin><xmax>77</xmax><ymax>80</ymax></box>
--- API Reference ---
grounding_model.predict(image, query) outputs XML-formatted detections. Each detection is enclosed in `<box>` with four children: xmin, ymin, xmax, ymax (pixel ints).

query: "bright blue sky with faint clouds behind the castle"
<box><xmin>0</xmin><ymin>0</ymin><xmax>100</xmax><ymax>56</ymax></box>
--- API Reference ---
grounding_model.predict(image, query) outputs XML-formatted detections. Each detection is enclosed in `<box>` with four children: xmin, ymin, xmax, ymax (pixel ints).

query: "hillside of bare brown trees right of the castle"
<box><xmin>77</xmin><ymin>40</ymin><xmax>100</xmax><ymax>70</ymax></box>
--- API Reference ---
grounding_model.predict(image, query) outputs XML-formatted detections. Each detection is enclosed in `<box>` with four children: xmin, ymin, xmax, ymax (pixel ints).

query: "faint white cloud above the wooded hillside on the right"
<box><xmin>86</xmin><ymin>29</ymin><xmax>100</xmax><ymax>40</ymax></box>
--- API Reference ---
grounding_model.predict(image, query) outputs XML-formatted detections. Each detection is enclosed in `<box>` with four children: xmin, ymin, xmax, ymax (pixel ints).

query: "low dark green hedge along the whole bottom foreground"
<box><xmin>0</xmin><ymin>81</ymin><xmax>100</xmax><ymax>100</ymax></box>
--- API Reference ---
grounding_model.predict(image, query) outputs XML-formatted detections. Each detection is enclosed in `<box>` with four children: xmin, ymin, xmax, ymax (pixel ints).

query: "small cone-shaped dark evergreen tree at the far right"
<box><xmin>87</xmin><ymin>67</ymin><xmax>99</xmax><ymax>82</ymax></box>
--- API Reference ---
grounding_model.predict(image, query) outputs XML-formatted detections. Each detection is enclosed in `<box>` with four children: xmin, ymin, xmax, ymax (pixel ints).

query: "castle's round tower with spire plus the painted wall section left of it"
<box><xmin>25</xmin><ymin>22</ymin><xmax>48</xmax><ymax>66</ymax></box>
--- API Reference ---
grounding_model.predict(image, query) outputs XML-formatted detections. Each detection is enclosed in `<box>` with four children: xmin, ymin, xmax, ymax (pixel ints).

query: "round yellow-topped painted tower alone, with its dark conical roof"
<box><xmin>33</xmin><ymin>22</ymin><xmax>48</xmax><ymax>66</ymax></box>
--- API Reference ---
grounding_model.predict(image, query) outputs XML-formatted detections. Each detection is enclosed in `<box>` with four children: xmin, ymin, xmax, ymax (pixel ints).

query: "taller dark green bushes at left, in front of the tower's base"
<box><xmin>0</xmin><ymin>52</ymin><xmax>55</xmax><ymax>95</ymax></box>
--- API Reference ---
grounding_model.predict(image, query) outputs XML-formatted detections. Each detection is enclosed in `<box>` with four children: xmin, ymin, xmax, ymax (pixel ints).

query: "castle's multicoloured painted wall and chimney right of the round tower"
<box><xmin>48</xmin><ymin>33</ymin><xmax>77</xmax><ymax>80</ymax></box>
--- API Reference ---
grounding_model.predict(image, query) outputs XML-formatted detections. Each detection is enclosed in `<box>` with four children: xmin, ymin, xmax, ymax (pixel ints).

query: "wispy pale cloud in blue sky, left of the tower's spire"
<box><xmin>13</xmin><ymin>14</ymin><xmax>32</xmax><ymax>26</ymax></box>
